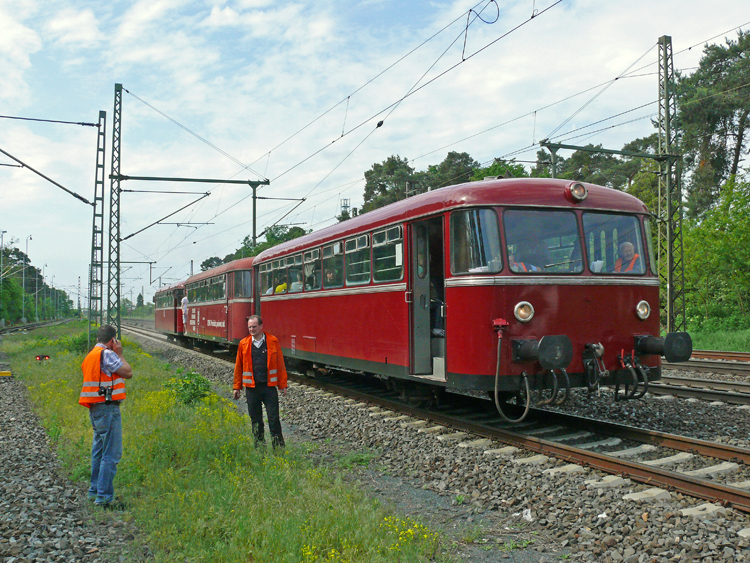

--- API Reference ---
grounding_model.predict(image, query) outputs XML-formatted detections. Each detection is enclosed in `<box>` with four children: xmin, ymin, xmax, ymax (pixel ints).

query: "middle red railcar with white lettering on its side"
<box><xmin>185</xmin><ymin>258</ymin><xmax>255</xmax><ymax>345</ymax></box>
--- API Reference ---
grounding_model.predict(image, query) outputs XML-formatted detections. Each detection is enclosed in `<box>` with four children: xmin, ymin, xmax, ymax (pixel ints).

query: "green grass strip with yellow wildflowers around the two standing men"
<box><xmin>2</xmin><ymin>324</ymin><xmax>447</xmax><ymax>563</ymax></box>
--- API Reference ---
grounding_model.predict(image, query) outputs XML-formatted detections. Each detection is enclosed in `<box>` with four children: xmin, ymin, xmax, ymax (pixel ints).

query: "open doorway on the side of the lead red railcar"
<box><xmin>409</xmin><ymin>217</ymin><xmax>445</xmax><ymax>380</ymax></box>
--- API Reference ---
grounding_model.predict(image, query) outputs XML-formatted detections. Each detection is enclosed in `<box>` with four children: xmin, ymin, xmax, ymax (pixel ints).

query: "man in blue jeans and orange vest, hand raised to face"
<box><xmin>78</xmin><ymin>325</ymin><xmax>133</xmax><ymax>508</ymax></box>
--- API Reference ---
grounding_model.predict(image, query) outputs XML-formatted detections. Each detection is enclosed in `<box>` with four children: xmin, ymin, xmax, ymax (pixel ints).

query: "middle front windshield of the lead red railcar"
<box><xmin>503</xmin><ymin>209</ymin><xmax>583</xmax><ymax>274</ymax></box>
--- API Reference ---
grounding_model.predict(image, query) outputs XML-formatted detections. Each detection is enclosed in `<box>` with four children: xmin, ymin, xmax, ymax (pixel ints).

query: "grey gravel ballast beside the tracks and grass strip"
<box><xmin>0</xmin><ymin>330</ymin><xmax>750</xmax><ymax>563</ymax></box>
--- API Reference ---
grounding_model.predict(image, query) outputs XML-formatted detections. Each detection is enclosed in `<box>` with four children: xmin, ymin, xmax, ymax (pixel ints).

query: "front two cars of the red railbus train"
<box><xmin>157</xmin><ymin>178</ymin><xmax>692</xmax><ymax>418</ymax></box>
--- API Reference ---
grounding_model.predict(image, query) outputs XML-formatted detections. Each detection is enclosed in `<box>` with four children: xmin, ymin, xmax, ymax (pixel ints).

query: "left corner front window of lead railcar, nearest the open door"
<box><xmin>451</xmin><ymin>209</ymin><xmax>503</xmax><ymax>274</ymax></box>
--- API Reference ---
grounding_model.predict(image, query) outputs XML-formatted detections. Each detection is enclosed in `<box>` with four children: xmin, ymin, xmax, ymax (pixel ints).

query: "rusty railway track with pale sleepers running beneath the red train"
<box><xmin>122</xmin><ymin>320</ymin><xmax>750</xmax><ymax>512</ymax></box>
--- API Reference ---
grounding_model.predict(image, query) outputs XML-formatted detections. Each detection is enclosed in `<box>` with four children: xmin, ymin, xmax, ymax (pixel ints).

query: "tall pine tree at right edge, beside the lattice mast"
<box><xmin>676</xmin><ymin>31</ymin><xmax>750</xmax><ymax>216</ymax></box>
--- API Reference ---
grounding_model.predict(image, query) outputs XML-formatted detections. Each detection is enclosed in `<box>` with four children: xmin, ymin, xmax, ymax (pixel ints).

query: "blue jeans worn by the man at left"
<box><xmin>89</xmin><ymin>403</ymin><xmax>122</xmax><ymax>504</ymax></box>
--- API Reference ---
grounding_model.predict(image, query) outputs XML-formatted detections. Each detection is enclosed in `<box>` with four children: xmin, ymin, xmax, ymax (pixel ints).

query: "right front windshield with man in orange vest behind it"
<box><xmin>583</xmin><ymin>213</ymin><xmax>646</xmax><ymax>275</ymax></box>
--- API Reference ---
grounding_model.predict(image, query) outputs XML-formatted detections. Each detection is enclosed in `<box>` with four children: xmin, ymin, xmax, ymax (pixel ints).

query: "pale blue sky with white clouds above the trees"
<box><xmin>0</xmin><ymin>0</ymin><xmax>750</xmax><ymax>306</ymax></box>
